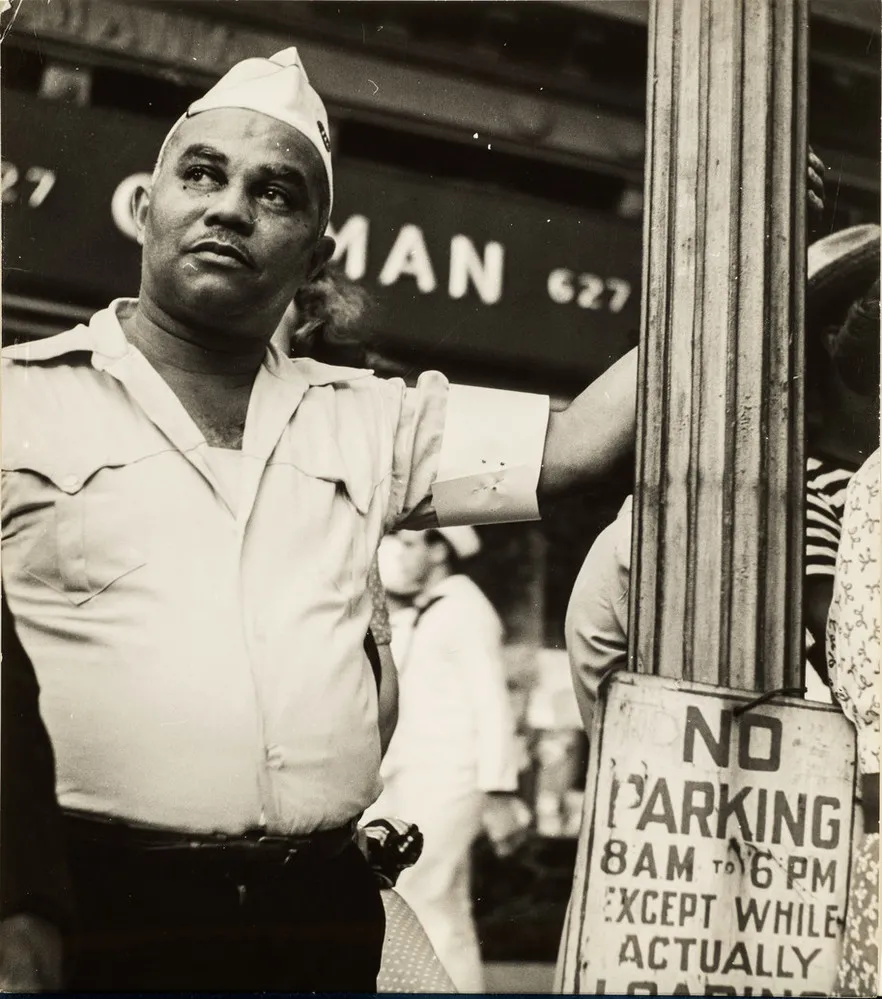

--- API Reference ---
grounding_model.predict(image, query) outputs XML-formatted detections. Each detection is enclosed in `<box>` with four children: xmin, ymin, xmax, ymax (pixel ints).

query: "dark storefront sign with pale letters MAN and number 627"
<box><xmin>2</xmin><ymin>92</ymin><xmax>641</xmax><ymax>379</ymax></box>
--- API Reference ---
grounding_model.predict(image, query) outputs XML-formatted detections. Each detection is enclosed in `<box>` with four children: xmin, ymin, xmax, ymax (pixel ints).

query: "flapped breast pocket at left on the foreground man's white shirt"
<box><xmin>6</xmin><ymin>458</ymin><xmax>147</xmax><ymax>606</ymax></box>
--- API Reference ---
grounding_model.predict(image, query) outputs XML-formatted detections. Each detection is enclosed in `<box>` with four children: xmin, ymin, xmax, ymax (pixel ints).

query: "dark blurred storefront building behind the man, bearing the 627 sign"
<box><xmin>2</xmin><ymin>0</ymin><xmax>880</xmax><ymax>961</ymax></box>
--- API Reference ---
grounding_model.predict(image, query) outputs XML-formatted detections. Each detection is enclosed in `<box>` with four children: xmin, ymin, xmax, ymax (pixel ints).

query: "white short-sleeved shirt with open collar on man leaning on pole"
<box><xmin>2</xmin><ymin>300</ymin><xmax>548</xmax><ymax>833</ymax></box>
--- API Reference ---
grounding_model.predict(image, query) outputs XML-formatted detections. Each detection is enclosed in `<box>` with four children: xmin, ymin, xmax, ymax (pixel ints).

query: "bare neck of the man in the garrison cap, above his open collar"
<box><xmin>120</xmin><ymin>297</ymin><xmax>272</xmax><ymax>384</ymax></box>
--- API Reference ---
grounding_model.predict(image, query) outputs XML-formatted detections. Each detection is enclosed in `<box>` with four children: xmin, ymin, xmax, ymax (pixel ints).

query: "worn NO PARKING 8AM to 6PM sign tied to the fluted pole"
<box><xmin>562</xmin><ymin>674</ymin><xmax>855</xmax><ymax>996</ymax></box>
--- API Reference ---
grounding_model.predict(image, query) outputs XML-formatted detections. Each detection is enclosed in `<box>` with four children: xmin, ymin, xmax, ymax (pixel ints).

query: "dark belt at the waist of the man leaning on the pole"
<box><xmin>65</xmin><ymin>810</ymin><xmax>356</xmax><ymax>866</ymax></box>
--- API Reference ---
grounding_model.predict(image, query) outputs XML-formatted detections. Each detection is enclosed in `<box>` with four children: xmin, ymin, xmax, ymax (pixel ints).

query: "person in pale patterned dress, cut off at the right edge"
<box><xmin>827</xmin><ymin>450</ymin><xmax>882</xmax><ymax>996</ymax></box>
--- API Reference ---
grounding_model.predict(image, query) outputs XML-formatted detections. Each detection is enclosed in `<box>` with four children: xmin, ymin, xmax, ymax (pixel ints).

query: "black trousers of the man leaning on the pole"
<box><xmin>69</xmin><ymin>828</ymin><xmax>385</xmax><ymax>992</ymax></box>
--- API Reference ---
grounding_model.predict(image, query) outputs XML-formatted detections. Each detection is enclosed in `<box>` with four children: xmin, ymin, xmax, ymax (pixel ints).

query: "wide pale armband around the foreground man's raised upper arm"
<box><xmin>432</xmin><ymin>385</ymin><xmax>549</xmax><ymax>527</ymax></box>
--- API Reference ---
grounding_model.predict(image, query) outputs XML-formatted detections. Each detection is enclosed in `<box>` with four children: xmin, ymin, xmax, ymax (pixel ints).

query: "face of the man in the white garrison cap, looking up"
<box><xmin>135</xmin><ymin>108</ymin><xmax>334</xmax><ymax>338</ymax></box>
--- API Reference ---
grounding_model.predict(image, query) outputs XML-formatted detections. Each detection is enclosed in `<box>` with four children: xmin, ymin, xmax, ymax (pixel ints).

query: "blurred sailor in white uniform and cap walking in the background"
<box><xmin>369</xmin><ymin>527</ymin><xmax>525</xmax><ymax>992</ymax></box>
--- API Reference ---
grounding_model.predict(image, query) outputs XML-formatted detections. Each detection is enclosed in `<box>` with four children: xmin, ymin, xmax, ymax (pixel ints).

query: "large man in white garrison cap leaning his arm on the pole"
<box><xmin>2</xmin><ymin>49</ymin><xmax>636</xmax><ymax>992</ymax></box>
